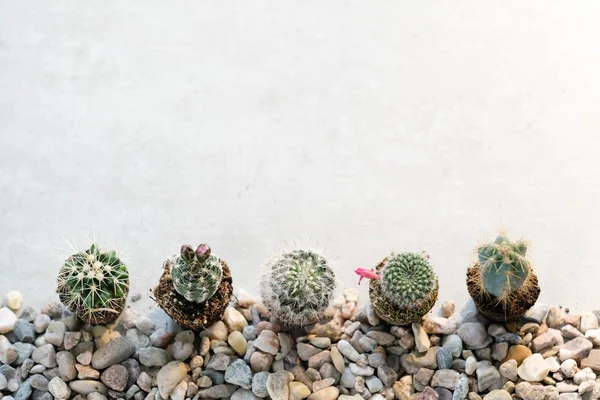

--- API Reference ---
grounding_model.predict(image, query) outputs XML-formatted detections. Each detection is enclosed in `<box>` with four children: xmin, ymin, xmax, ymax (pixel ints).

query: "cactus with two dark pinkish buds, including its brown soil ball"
<box><xmin>154</xmin><ymin>244</ymin><xmax>233</xmax><ymax>330</ymax></box>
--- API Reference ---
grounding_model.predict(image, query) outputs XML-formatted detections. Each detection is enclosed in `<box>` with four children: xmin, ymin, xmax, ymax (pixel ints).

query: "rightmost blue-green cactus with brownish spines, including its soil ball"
<box><xmin>467</xmin><ymin>234</ymin><xmax>540</xmax><ymax>321</ymax></box>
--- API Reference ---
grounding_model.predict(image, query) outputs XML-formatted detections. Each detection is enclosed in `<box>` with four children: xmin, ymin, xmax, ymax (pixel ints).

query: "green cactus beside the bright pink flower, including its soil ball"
<box><xmin>369</xmin><ymin>253</ymin><xmax>439</xmax><ymax>325</ymax></box>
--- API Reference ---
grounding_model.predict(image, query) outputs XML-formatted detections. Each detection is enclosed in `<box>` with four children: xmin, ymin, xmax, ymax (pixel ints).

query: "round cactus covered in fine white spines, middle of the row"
<box><xmin>261</xmin><ymin>250</ymin><xmax>335</xmax><ymax>326</ymax></box>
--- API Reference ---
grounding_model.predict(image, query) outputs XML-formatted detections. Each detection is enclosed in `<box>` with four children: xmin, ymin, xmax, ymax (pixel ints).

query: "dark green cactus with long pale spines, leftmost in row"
<box><xmin>57</xmin><ymin>243</ymin><xmax>129</xmax><ymax>324</ymax></box>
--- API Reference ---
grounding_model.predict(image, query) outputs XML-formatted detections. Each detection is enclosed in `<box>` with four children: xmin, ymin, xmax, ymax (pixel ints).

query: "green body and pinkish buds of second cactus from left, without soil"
<box><xmin>171</xmin><ymin>244</ymin><xmax>223</xmax><ymax>303</ymax></box>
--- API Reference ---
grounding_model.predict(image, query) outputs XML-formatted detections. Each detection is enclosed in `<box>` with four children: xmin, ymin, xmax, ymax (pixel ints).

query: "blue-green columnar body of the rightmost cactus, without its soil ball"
<box><xmin>477</xmin><ymin>235</ymin><xmax>531</xmax><ymax>300</ymax></box>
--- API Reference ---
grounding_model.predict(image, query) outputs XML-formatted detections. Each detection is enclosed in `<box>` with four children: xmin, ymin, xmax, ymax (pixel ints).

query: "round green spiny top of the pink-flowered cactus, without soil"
<box><xmin>381</xmin><ymin>253</ymin><xmax>438</xmax><ymax>308</ymax></box>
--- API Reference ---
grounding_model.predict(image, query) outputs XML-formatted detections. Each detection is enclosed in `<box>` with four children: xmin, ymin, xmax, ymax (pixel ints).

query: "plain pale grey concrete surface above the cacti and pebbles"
<box><xmin>0</xmin><ymin>0</ymin><xmax>600</xmax><ymax>316</ymax></box>
